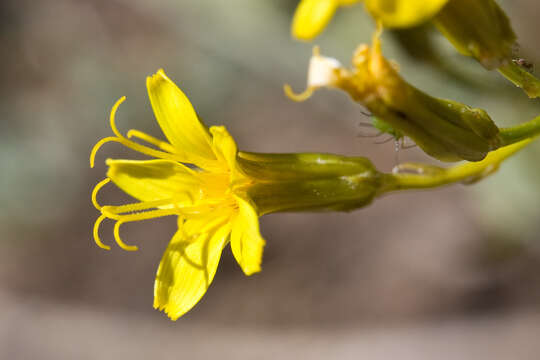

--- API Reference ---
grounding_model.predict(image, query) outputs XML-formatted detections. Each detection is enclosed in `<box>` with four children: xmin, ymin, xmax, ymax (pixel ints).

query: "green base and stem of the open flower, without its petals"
<box><xmin>237</xmin><ymin>134</ymin><xmax>540</xmax><ymax>215</ymax></box>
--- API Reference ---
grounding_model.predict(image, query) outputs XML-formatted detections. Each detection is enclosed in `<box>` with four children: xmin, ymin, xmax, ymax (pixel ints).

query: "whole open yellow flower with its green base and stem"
<box><xmin>90</xmin><ymin>70</ymin><xmax>540</xmax><ymax>320</ymax></box>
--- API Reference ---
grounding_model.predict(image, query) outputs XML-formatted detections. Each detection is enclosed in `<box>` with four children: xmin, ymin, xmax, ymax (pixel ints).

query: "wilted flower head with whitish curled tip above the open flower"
<box><xmin>286</xmin><ymin>34</ymin><xmax>500</xmax><ymax>161</ymax></box>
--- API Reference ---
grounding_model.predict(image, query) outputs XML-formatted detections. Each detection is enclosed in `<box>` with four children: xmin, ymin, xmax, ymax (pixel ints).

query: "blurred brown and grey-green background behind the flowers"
<box><xmin>0</xmin><ymin>0</ymin><xmax>540</xmax><ymax>360</ymax></box>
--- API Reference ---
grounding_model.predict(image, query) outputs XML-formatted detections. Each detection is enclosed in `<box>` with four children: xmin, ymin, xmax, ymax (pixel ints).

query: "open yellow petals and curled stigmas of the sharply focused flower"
<box><xmin>90</xmin><ymin>70</ymin><xmax>265</xmax><ymax>320</ymax></box>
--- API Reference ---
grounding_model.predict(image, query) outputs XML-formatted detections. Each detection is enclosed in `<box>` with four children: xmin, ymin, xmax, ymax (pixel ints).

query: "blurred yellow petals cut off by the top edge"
<box><xmin>291</xmin><ymin>0</ymin><xmax>448</xmax><ymax>40</ymax></box>
